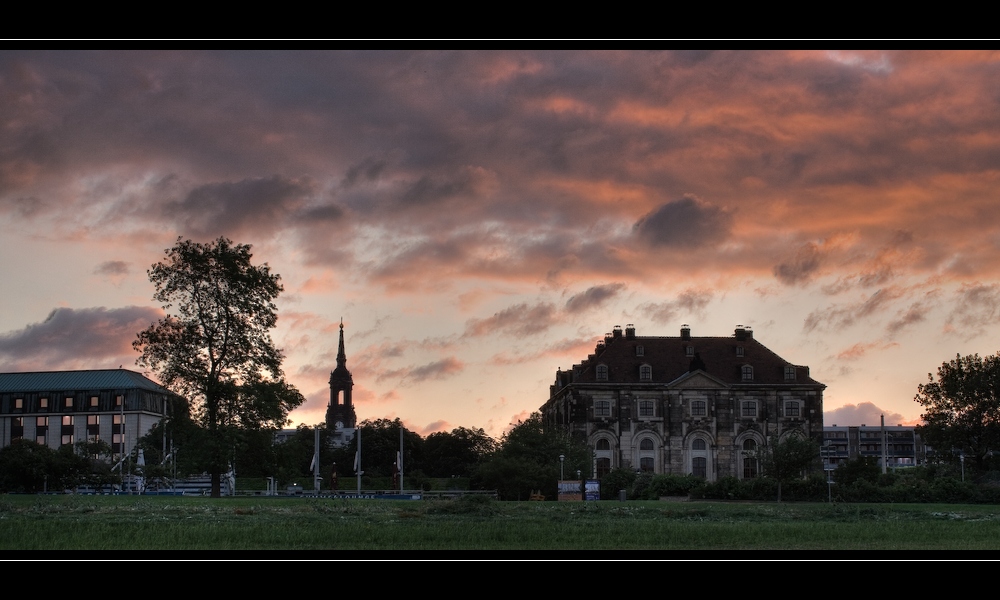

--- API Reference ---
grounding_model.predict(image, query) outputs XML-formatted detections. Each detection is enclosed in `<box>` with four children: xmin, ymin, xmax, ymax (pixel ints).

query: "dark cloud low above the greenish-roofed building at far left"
<box><xmin>0</xmin><ymin>306</ymin><xmax>163</xmax><ymax>371</ymax></box>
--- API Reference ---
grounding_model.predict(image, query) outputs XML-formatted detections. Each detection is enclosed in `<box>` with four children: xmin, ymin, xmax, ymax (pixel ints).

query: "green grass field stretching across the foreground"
<box><xmin>0</xmin><ymin>495</ymin><xmax>1000</xmax><ymax>551</ymax></box>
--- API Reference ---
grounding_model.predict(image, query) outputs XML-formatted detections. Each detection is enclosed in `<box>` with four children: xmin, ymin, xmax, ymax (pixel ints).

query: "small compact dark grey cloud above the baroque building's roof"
<box><xmin>633</xmin><ymin>196</ymin><xmax>732</xmax><ymax>249</ymax></box>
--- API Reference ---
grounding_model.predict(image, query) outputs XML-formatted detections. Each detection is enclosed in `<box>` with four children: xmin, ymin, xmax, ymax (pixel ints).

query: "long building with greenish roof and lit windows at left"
<box><xmin>0</xmin><ymin>369</ymin><xmax>184</xmax><ymax>455</ymax></box>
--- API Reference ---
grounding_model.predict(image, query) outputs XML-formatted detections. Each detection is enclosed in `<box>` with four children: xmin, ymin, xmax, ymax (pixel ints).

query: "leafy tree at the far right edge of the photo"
<box><xmin>914</xmin><ymin>353</ymin><xmax>1000</xmax><ymax>472</ymax></box>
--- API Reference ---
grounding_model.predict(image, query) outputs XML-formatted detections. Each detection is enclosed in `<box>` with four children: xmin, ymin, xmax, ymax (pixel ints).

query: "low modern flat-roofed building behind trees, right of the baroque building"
<box><xmin>823</xmin><ymin>424</ymin><xmax>933</xmax><ymax>469</ymax></box>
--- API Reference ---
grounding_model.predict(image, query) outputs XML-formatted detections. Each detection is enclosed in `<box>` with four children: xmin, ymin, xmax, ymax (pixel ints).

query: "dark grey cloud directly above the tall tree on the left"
<box><xmin>164</xmin><ymin>176</ymin><xmax>312</xmax><ymax>237</ymax></box>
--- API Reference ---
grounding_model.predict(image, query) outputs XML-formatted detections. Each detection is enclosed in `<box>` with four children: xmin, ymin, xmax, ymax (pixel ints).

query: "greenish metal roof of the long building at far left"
<box><xmin>0</xmin><ymin>369</ymin><xmax>172</xmax><ymax>394</ymax></box>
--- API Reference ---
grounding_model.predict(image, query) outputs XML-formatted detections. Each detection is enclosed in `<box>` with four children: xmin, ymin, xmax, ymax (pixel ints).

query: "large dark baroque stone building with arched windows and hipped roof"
<box><xmin>541</xmin><ymin>325</ymin><xmax>826</xmax><ymax>481</ymax></box>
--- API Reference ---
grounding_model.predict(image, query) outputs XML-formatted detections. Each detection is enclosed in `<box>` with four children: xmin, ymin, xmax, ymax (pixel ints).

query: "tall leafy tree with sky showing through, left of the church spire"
<box><xmin>132</xmin><ymin>237</ymin><xmax>304</xmax><ymax>497</ymax></box>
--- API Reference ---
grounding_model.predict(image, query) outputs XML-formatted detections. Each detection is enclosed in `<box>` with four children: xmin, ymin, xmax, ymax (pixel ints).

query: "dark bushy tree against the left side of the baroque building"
<box><xmin>473</xmin><ymin>413</ymin><xmax>591</xmax><ymax>500</ymax></box>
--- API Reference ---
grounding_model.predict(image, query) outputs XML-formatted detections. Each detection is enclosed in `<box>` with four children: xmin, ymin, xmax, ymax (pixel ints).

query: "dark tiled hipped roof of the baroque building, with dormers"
<box><xmin>560</xmin><ymin>329</ymin><xmax>823</xmax><ymax>386</ymax></box>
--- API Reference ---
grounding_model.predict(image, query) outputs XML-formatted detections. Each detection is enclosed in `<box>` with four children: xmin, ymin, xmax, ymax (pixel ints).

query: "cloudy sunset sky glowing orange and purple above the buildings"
<box><xmin>0</xmin><ymin>51</ymin><xmax>1000</xmax><ymax>436</ymax></box>
